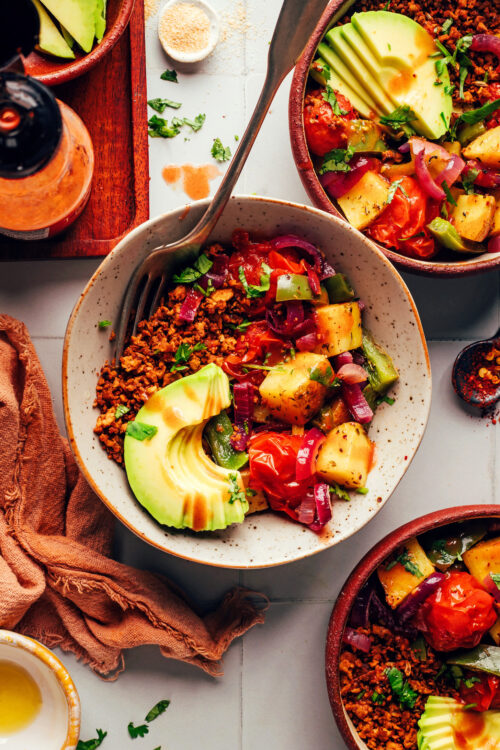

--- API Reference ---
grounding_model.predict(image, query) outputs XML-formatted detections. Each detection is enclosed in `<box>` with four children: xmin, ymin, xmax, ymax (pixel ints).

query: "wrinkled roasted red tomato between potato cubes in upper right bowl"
<box><xmin>366</xmin><ymin>177</ymin><xmax>436</xmax><ymax>258</ymax></box>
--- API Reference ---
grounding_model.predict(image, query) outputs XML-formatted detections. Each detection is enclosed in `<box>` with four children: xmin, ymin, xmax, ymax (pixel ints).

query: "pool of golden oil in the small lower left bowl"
<box><xmin>0</xmin><ymin>660</ymin><xmax>42</xmax><ymax>737</ymax></box>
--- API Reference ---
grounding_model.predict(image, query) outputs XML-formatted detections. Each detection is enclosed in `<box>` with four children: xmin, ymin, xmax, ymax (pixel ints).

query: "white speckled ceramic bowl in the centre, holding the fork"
<box><xmin>63</xmin><ymin>196</ymin><xmax>431</xmax><ymax>568</ymax></box>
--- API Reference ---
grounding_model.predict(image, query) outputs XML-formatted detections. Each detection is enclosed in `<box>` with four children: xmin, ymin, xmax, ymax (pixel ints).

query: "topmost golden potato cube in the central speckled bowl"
<box><xmin>314</xmin><ymin>302</ymin><xmax>363</xmax><ymax>357</ymax></box>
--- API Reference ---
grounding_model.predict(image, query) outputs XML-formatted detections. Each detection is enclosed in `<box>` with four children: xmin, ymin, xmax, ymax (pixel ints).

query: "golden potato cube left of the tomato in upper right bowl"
<box><xmin>337</xmin><ymin>172</ymin><xmax>389</xmax><ymax>229</ymax></box>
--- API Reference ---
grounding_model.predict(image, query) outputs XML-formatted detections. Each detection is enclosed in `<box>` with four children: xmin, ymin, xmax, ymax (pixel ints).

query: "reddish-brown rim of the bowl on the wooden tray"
<box><xmin>25</xmin><ymin>0</ymin><xmax>135</xmax><ymax>86</ymax></box>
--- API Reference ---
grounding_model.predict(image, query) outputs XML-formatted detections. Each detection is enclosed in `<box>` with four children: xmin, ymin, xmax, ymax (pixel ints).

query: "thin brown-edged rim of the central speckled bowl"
<box><xmin>62</xmin><ymin>193</ymin><xmax>432</xmax><ymax>570</ymax></box>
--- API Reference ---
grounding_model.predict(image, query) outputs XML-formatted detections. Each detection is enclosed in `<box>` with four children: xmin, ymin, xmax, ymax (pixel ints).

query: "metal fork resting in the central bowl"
<box><xmin>115</xmin><ymin>0</ymin><xmax>336</xmax><ymax>364</ymax></box>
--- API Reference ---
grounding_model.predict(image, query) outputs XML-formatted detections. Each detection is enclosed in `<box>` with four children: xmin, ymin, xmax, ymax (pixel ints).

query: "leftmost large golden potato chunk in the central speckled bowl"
<box><xmin>259</xmin><ymin>352</ymin><xmax>333</xmax><ymax>424</ymax></box>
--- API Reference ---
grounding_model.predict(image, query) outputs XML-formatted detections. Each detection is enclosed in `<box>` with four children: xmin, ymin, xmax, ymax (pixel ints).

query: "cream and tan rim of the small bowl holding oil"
<box><xmin>0</xmin><ymin>629</ymin><xmax>81</xmax><ymax>750</ymax></box>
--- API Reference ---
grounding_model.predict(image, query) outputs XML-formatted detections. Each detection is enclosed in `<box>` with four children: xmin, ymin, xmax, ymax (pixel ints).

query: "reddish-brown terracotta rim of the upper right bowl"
<box><xmin>289</xmin><ymin>0</ymin><xmax>500</xmax><ymax>277</ymax></box>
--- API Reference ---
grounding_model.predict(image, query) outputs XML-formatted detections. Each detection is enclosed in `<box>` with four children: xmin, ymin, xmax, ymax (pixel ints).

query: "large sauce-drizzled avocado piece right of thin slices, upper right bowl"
<box><xmin>350</xmin><ymin>10</ymin><xmax>452</xmax><ymax>139</ymax></box>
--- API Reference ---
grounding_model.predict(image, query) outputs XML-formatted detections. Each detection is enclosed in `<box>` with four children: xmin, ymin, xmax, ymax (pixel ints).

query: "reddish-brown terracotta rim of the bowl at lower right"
<box><xmin>325</xmin><ymin>505</ymin><xmax>500</xmax><ymax>750</ymax></box>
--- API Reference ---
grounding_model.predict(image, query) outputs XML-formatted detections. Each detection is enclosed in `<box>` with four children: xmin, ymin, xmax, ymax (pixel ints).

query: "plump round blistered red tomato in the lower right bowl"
<box><xmin>422</xmin><ymin>573</ymin><xmax>497</xmax><ymax>651</ymax></box>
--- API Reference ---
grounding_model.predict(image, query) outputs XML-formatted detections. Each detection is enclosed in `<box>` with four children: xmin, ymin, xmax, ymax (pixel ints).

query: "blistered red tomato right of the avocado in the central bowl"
<box><xmin>248</xmin><ymin>432</ymin><xmax>310</xmax><ymax>520</ymax></box>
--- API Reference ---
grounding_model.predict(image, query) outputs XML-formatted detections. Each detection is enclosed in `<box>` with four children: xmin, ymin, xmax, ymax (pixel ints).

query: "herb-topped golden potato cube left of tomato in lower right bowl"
<box><xmin>377</xmin><ymin>539</ymin><xmax>434</xmax><ymax>609</ymax></box>
